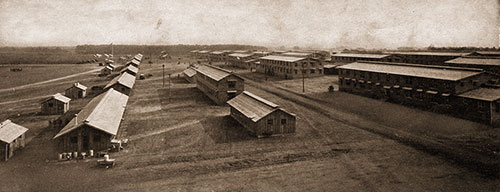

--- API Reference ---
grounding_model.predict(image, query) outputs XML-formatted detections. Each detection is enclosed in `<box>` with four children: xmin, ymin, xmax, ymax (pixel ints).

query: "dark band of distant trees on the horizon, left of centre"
<box><xmin>76</xmin><ymin>44</ymin><xmax>267</xmax><ymax>55</ymax></box>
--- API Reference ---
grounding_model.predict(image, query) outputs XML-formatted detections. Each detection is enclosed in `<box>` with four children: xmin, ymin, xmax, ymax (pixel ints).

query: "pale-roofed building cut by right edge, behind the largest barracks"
<box><xmin>444</xmin><ymin>56</ymin><xmax>500</xmax><ymax>74</ymax></box>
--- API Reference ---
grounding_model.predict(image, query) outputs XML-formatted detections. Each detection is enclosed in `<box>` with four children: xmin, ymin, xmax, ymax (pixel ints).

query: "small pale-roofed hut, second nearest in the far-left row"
<box><xmin>40</xmin><ymin>93</ymin><xmax>71</xmax><ymax>115</ymax></box>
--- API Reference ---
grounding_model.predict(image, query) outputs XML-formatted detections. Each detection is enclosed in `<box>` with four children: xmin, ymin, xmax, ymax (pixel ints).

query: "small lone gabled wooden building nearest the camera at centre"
<box><xmin>227</xmin><ymin>91</ymin><xmax>296</xmax><ymax>137</ymax></box>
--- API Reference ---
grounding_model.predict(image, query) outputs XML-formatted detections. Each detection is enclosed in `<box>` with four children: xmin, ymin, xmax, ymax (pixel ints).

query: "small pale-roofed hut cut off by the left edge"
<box><xmin>0</xmin><ymin>120</ymin><xmax>28</xmax><ymax>161</ymax></box>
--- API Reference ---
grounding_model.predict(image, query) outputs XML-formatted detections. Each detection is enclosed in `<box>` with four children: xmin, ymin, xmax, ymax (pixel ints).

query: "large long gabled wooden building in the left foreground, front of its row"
<box><xmin>53</xmin><ymin>88</ymin><xmax>128</xmax><ymax>154</ymax></box>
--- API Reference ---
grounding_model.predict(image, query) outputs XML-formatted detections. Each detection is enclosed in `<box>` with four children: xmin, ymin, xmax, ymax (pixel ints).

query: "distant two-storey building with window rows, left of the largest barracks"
<box><xmin>257</xmin><ymin>55</ymin><xmax>323</xmax><ymax>79</ymax></box>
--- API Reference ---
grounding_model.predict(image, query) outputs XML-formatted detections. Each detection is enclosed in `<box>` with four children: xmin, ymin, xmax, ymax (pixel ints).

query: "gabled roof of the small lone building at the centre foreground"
<box><xmin>227</xmin><ymin>91</ymin><xmax>293</xmax><ymax>122</ymax></box>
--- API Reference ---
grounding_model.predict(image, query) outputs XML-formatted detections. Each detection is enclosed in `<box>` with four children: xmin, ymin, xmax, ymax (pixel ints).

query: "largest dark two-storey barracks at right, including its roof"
<box><xmin>339</xmin><ymin>61</ymin><xmax>500</xmax><ymax>123</ymax></box>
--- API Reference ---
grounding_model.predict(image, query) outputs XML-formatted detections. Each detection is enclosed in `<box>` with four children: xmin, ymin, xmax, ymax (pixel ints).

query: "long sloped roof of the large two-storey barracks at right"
<box><xmin>338</xmin><ymin>62</ymin><xmax>482</xmax><ymax>81</ymax></box>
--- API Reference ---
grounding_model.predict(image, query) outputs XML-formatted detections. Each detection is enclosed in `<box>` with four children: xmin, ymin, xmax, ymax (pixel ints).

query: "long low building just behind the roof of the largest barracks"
<box><xmin>384</xmin><ymin>52</ymin><xmax>468</xmax><ymax>65</ymax></box>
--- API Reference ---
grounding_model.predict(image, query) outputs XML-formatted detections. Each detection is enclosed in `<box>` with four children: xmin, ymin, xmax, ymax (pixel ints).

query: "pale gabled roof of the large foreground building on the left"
<box><xmin>54</xmin><ymin>88</ymin><xmax>128</xmax><ymax>139</ymax></box>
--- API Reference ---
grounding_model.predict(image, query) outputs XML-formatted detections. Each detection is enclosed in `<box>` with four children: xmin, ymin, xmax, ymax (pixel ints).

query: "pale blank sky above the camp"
<box><xmin>0</xmin><ymin>0</ymin><xmax>500</xmax><ymax>48</ymax></box>
